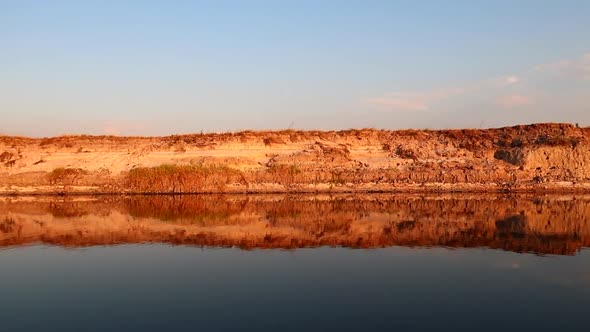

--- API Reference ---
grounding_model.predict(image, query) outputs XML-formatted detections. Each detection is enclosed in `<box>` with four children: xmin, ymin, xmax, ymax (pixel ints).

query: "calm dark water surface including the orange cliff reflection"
<box><xmin>0</xmin><ymin>195</ymin><xmax>590</xmax><ymax>331</ymax></box>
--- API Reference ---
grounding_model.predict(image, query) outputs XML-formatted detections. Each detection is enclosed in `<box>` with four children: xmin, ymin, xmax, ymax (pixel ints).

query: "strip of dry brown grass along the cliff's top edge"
<box><xmin>0</xmin><ymin>123</ymin><xmax>590</xmax><ymax>150</ymax></box>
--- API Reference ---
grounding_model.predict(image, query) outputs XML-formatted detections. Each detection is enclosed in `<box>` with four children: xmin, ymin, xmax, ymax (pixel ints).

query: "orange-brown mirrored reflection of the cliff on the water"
<box><xmin>0</xmin><ymin>195</ymin><xmax>590</xmax><ymax>254</ymax></box>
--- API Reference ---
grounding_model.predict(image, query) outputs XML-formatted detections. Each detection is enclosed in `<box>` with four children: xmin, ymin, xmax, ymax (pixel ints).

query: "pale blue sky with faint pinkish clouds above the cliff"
<box><xmin>0</xmin><ymin>0</ymin><xmax>590</xmax><ymax>137</ymax></box>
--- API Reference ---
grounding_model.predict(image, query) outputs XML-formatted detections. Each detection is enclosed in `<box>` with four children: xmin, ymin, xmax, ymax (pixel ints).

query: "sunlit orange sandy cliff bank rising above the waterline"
<box><xmin>0</xmin><ymin>124</ymin><xmax>590</xmax><ymax>193</ymax></box>
